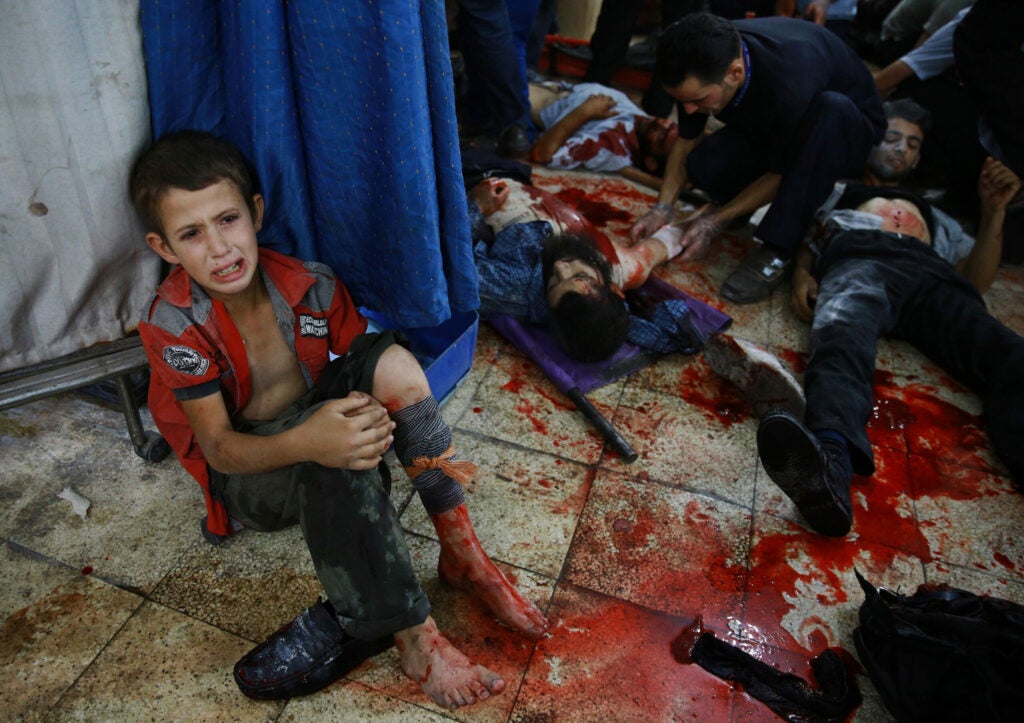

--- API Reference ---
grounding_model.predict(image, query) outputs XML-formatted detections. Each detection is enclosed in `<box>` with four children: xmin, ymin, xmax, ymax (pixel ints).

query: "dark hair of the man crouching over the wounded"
<box><xmin>656</xmin><ymin>12</ymin><xmax>742</xmax><ymax>88</ymax></box>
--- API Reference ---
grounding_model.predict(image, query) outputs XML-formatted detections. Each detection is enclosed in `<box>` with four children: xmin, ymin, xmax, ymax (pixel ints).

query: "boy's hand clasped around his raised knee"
<box><xmin>299</xmin><ymin>391</ymin><xmax>394</xmax><ymax>470</ymax></box>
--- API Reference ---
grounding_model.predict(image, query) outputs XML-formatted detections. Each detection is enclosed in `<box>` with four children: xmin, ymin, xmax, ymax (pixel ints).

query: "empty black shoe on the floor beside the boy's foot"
<box><xmin>234</xmin><ymin>600</ymin><xmax>394</xmax><ymax>700</ymax></box>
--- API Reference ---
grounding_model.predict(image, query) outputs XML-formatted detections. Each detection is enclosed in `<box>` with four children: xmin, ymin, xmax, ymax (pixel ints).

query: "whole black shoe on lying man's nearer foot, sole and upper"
<box><xmin>758</xmin><ymin>410</ymin><xmax>853</xmax><ymax>538</ymax></box>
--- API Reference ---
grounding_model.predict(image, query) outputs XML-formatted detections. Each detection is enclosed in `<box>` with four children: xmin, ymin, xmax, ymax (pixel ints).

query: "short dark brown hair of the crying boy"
<box><xmin>128</xmin><ymin>130</ymin><xmax>257</xmax><ymax>236</ymax></box>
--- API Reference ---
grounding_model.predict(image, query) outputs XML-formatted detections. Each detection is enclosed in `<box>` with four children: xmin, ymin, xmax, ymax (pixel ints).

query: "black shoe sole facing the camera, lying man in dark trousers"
<box><xmin>758</xmin><ymin>415</ymin><xmax>852</xmax><ymax>538</ymax></box>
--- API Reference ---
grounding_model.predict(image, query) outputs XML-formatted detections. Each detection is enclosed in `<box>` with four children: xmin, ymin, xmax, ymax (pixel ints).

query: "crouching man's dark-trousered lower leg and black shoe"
<box><xmin>721</xmin><ymin>91</ymin><xmax>878</xmax><ymax>304</ymax></box>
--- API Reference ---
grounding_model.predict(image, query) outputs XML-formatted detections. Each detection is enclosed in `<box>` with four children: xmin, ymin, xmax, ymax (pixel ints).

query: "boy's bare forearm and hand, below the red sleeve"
<box><xmin>181</xmin><ymin>392</ymin><xmax>394</xmax><ymax>474</ymax></box>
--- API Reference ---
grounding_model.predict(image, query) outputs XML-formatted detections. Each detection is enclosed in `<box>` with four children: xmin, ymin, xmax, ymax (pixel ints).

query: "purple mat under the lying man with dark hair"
<box><xmin>487</xmin><ymin>277</ymin><xmax>732</xmax><ymax>394</ymax></box>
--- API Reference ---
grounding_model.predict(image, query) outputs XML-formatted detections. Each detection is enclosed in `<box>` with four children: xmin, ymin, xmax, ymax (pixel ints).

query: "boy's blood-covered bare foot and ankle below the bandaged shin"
<box><xmin>431</xmin><ymin>505</ymin><xmax>548</xmax><ymax>640</ymax></box>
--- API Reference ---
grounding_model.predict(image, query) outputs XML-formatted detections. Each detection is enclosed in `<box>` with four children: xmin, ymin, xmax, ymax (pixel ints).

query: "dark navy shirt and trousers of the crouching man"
<box><xmin>679</xmin><ymin>17</ymin><xmax>886</xmax><ymax>257</ymax></box>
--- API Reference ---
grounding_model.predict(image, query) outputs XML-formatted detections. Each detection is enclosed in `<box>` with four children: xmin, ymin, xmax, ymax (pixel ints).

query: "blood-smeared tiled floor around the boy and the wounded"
<box><xmin>0</xmin><ymin>165</ymin><xmax>1024</xmax><ymax>721</ymax></box>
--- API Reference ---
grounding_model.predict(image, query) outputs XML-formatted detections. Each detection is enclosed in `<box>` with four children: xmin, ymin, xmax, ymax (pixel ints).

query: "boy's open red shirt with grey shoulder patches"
<box><xmin>139</xmin><ymin>248</ymin><xmax>367</xmax><ymax>536</ymax></box>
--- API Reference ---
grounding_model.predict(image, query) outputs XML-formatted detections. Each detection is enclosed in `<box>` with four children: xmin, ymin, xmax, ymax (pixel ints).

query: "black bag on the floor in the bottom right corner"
<box><xmin>853</xmin><ymin>572</ymin><xmax>1024</xmax><ymax>722</ymax></box>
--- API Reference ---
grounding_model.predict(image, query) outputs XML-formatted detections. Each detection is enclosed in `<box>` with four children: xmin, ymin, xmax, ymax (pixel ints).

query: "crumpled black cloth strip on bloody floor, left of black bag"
<box><xmin>690</xmin><ymin>633</ymin><xmax>862</xmax><ymax>723</ymax></box>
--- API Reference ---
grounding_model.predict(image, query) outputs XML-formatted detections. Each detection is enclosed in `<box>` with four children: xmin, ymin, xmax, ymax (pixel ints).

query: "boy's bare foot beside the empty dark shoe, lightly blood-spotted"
<box><xmin>394</xmin><ymin>618</ymin><xmax>505</xmax><ymax>710</ymax></box>
